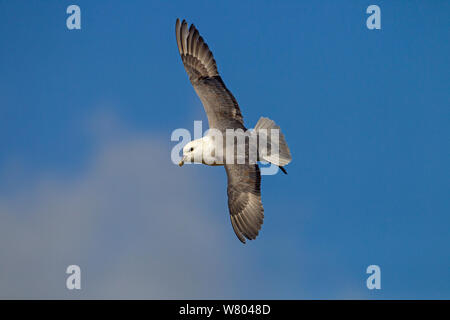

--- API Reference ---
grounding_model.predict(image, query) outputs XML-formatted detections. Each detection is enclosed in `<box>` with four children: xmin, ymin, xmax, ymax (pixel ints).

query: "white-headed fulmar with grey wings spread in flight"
<box><xmin>175</xmin><ymin>19</ymin><xmax>292</xmax><ymax>243</ymax></box>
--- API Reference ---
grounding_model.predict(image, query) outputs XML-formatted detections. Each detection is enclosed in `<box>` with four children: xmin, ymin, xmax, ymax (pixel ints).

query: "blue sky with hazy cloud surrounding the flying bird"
<box><xmin>0</xmin><ymin>0</ymin><xmax>450</xmax><ymax>299</ymax></box>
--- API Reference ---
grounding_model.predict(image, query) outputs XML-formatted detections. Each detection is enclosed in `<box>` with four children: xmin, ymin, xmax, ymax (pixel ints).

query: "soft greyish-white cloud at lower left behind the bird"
<box><xmin>0</xmin><ymin>115</ymin><xmax>246</xmax><ymax>299</ymax></box>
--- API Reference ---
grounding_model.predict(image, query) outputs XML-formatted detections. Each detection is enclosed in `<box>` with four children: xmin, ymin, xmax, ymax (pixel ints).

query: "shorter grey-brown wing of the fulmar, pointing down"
<box><xmin>225</xmin><ymin>164</ymin><xmax>264</xmax><ymax>243</ymax></box>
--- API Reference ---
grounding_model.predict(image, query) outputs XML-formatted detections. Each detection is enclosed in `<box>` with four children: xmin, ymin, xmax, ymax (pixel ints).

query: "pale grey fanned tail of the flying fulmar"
<box><xmin>254</xmin><ymin>117</ymin><xmax>292</xmax><ymax>168</ymax></box>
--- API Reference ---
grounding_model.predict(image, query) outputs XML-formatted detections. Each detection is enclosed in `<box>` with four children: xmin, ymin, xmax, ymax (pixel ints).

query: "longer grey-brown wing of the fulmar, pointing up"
<box><xmin>175</xmin><ymin>19</ymin><xmax>243</xmax><ymax>129</ymax></box>
